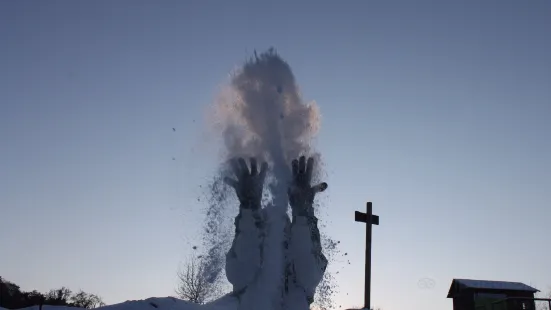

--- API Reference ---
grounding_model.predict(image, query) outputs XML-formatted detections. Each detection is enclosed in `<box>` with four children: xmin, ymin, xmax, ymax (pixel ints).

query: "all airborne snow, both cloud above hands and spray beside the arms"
<box><xmin>194</xmin><ymin>49</ymin><xmax>336</xmax><ymax>308</ymax></box>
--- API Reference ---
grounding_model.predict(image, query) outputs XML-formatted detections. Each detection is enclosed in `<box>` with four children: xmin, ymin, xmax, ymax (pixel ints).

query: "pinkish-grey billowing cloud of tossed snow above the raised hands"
<box><xmin>214</xmin><ymin>49</ymin><xmax>320</xmax><ymax>206</ymax></box>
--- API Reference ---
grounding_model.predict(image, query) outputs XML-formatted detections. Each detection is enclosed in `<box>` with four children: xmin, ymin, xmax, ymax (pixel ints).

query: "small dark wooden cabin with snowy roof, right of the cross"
<box><xmin>447</xmin><ymin>279</ymin><xmax>539</xmax><ymax>310</ymax></box>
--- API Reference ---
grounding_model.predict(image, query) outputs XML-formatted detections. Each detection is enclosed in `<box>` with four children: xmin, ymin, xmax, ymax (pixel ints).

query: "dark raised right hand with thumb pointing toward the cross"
<box><xmin>287</xmin><ymin>156</ymin><xmax>327</xmax><ymax>216</ymax></box>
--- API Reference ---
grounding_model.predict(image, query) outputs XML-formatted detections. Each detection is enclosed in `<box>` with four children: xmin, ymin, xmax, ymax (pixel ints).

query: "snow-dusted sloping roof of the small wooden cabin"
<box><xmin>447</xmin><ymin>279</ymin><xmax>539</xmax><ymax>298</ymax></box>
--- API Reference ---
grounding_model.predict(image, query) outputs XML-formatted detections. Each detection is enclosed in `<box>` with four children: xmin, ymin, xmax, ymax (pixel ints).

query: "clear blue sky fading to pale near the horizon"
<box><xmin>0</xmin><ymin>0</ymin><xmax>551</xmax><ymax>310</ymax></box>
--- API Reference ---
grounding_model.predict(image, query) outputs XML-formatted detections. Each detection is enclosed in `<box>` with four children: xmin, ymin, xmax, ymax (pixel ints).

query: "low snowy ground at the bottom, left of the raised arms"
<box><xmin>5</xmin><ymin>296</ymin><xmax>237</xmax><ymax>310</ymax></box>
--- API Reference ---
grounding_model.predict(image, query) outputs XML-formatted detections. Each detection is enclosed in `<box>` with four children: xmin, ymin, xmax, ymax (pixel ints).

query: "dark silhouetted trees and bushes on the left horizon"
<box><xmin>0</xmin><ymin>277</ymin><xmax>105</xmax><ymax>309</ymax></box>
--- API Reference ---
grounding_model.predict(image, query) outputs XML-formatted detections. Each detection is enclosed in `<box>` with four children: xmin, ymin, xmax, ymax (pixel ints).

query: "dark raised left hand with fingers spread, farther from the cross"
<box><xmin>224</xmin><ymin>158</ymin><xmax>268</xmax><ymax>210</ymax></box>
